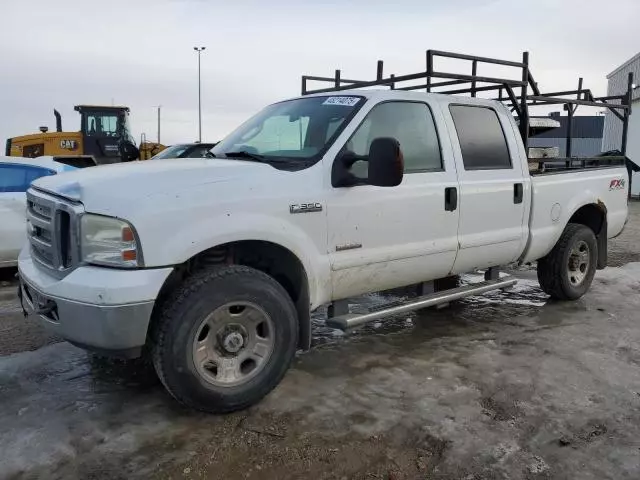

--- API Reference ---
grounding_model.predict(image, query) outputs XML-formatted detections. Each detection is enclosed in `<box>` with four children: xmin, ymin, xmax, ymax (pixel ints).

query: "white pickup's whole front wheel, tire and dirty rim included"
<box><xmin>152</xmin><ymin>266</ymin><xmax>298</xmax><ymax>413</ymax></box>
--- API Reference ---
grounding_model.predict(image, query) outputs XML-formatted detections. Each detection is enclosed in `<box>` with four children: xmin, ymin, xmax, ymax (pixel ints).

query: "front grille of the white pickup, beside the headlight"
<box><xmin>27</xmin><ymin>188</ymin><xmax>82</xmax><ymax>276</ymax></box>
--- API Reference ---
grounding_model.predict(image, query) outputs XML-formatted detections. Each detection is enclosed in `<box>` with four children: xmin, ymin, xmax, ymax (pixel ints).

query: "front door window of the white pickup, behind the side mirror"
<box><xmin>345</xmin><ymin>102</ymin><xmax>442</xmax><ymax>177</ymax></box>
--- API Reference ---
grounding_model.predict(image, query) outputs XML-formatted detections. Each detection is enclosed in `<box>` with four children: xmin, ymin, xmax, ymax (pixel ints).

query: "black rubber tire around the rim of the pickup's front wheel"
<box><xmin>150</xmin><ymin>265</ymin><xmax>298</xmax><ymax>413</ymax></box>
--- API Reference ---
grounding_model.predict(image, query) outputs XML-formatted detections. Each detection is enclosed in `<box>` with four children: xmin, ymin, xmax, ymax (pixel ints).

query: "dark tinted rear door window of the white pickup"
<box><xmin>449</xmin><ymin>105</ymin><xmax>511</xmax><ymax>170</ymax></box>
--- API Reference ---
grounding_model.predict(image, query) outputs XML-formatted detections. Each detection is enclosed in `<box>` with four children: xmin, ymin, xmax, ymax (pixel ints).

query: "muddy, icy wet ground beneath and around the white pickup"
<box><xmin>0</xmin><ymin>203</ymin><xmax>640</xmax><ymax>480</ymax></box>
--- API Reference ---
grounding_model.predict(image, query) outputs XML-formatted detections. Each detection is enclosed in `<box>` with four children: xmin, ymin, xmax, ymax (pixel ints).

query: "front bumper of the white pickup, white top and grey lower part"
<box><xmin>18</xmin><ymin>248</ymin><xmax>172</xmax><ymax>357</ymax></box>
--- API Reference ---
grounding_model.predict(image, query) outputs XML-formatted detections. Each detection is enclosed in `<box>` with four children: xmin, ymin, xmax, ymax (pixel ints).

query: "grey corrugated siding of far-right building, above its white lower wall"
<box><xmin>602</xmin><ymin>53</ymin><xmax>640</xmax><ymax>152</ymax></box>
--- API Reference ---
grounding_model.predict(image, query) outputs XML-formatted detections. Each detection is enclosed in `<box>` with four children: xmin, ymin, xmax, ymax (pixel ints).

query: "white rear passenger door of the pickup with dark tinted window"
<box><xmin>443</xmin><ymin>103</ymin><xmax>529</xmax><ymax>273</ymax></box>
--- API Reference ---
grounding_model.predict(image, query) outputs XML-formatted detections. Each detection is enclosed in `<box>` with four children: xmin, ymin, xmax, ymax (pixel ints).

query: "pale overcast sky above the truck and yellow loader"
<box><xmin>0</xmin><ymin>0</ymin><xmax>640</xmax><ymax>144</ymax></box>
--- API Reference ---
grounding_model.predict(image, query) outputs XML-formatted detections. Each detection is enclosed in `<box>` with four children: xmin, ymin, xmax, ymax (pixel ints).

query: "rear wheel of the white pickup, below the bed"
<box><xmin>538</xmin><ymin>223</ymin><xmax>598</xmax><ymax>300</ymax></box>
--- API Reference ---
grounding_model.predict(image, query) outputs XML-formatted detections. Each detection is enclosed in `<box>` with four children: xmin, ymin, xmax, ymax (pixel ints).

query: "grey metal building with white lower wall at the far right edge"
<box><xmin>602</xmin><ymin>53</ymin><xmax>640</xmax><ymax>196</ymax></box>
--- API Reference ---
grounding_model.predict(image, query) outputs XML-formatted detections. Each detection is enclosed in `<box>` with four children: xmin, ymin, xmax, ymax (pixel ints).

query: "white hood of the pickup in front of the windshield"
<box><xmin>33</xmin><ymin>159</ymin><xmax>272</xmax><ymax>207</ymax></box>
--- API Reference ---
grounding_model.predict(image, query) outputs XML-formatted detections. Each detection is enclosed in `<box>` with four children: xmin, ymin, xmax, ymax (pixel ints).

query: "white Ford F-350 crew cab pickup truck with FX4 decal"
<box><xmin>19</xmin><ymin>76</ymin><xmax>627</xmax><ymax>412</ymax></box>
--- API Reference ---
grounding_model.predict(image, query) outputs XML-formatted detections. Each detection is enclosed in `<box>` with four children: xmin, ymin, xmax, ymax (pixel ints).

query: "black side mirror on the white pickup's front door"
<box><xmin>367</xmin><ymin>137</ymin><xmax>404</xmax><ymax>187</ymax></box>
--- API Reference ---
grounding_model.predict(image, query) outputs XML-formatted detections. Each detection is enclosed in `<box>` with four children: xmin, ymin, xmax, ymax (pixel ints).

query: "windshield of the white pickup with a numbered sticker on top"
<box><xmin>211</xmin><ymin>96</ymin><xmax>365</xmax><ymax>161</ymax></box>
